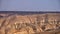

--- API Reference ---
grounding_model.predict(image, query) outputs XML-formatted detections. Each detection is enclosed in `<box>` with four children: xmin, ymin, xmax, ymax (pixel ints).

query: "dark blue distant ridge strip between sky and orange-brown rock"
<box><xmin>0</xmin><ymin>11</ymin><xmax>60</xmax><ymax>14</ymax></box>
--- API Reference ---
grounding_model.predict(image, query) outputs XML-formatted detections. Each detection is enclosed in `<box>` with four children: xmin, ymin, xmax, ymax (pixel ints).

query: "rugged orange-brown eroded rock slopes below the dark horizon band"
<box><xmin>0</xmin><ymin>13</ymin><xmax>60</xmax><ymax>34</ymax></box>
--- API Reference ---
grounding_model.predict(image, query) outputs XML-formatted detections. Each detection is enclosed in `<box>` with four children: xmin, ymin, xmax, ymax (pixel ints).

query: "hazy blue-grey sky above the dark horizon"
<box><xmin>0</xmin><ymin>0</ymin><xmax>60</xmax><ymax>11</ymax></box>
